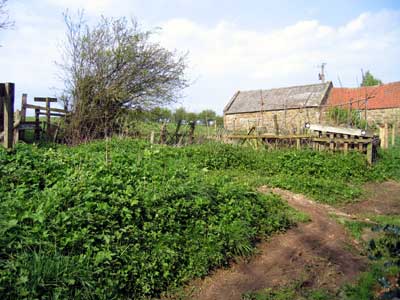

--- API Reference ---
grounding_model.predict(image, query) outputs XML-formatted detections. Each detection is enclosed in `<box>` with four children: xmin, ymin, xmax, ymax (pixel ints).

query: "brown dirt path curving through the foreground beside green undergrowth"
<box><xmin>190</xmin><ymin>187</ymin><xmax>366</xmax><ymax>300</ymax></box>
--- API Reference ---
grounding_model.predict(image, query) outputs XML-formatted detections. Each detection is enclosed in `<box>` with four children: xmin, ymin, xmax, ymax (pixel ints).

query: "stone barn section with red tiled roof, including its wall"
<box><xmin>328</xmin><ymin>81</ymin><xmax>400</xmax><ymax>124</ymax></box>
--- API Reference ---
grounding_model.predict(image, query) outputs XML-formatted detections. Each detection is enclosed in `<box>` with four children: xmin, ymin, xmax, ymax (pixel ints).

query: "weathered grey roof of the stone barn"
<box><xmin>224</xmin><ymin>81</ymin><xmax>332</xmax><ymax>114</ymax></box>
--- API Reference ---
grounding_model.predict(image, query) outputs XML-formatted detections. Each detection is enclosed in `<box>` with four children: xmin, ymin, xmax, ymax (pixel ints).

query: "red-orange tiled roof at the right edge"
<box><xmin>328</xmin><ymin>81</ymin><xmax>400</xmax><ymax>109</ymax></box>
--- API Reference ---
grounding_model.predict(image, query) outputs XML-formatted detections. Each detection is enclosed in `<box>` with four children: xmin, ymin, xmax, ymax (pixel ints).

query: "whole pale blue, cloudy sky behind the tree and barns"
<box><xmin>0</xmin><ymin>0</ymin><xmax>400</xmax><ymax>114</ymax></box>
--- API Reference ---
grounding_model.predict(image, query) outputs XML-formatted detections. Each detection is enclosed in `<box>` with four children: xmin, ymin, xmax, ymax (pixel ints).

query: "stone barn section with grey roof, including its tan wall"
<box><xmin>224</xmin><ymin>82</ymin><xmax>332</xmax><ymax>134</ymax></box>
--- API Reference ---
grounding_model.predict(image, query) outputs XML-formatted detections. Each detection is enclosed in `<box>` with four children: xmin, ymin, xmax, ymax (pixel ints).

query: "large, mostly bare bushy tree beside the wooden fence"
<box><xmin>59</xmin><ymin>13</ymin><xmax>187</xmax><ymax>142</ymax></box>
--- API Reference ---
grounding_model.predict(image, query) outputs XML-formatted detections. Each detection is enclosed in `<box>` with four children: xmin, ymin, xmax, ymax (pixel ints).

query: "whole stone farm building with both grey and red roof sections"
<box><xmin>224</xmin><ymin>82</ymin><xmax>400</xmax><ymax>133</ymax></box>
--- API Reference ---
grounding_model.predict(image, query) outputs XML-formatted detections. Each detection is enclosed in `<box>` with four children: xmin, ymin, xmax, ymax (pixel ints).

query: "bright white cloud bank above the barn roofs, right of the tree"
<box><xmin>160</xmin><ymin>11</ymin><xmax>400</xmax><ymax>111</ymax></box>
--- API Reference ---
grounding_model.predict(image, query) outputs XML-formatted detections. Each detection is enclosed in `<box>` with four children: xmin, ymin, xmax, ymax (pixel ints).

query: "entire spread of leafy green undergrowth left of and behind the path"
<box><xmin>0</xmin><ymin>139</ymin><xmax>400</xmax><ymax>299</ymax></box>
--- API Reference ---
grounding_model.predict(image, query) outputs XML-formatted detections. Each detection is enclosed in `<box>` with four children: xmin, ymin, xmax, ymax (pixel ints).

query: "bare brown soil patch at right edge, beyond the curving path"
<box><xmin>341</xmin><ymin>181</ymin><xmax>400</xmax><ymax>215</ymax></box>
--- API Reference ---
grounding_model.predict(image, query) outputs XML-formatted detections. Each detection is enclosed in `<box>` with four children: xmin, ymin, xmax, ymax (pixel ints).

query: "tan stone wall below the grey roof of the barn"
<box><xmin>224</xmin><ymin>108</ymin><xmax>322</xmax><ymax>134</ymax></box>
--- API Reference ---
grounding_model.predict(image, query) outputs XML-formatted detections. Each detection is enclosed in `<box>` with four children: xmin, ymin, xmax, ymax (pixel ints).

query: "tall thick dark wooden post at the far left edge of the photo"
<box><xmin>3</xmin><ymin>82</ymin><xmax>15</xmax><ymax>149</ymax></box>
